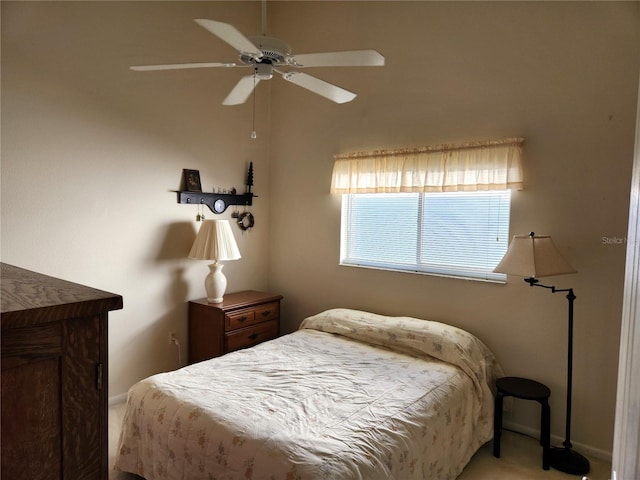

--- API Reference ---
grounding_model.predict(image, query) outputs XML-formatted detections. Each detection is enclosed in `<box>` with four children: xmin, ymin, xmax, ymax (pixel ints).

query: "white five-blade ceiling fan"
<box><xmin>130</xmin><ymin>19</ymin><xmax>384</xmax><ymax>105</ymax></box>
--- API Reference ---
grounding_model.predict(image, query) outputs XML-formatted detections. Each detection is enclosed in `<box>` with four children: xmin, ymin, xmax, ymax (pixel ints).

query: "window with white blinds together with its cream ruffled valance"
<box><xmin>331</xmin><ymin>138</ymin><xmax>524</xmax><ymax>281</ymax></box>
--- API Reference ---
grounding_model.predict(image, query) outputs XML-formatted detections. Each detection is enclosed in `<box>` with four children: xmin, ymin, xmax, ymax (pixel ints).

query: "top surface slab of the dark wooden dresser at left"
<box><xmin>0</xmin><ymin>263</ymin><xmax>122</xmax><ymax>329</ymax></box>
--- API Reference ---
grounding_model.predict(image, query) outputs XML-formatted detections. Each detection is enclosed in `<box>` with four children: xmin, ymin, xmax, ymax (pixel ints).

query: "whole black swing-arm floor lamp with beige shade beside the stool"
<box><xmin>493</xmin><ymin>232</ymin><xmax>589</xmax><ymax>475</ymax></box>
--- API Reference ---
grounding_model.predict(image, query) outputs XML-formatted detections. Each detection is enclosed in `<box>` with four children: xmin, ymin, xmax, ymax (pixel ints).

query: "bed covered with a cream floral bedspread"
<box><xmin>115</xmin><ymin>309</ymin><xmax>502</xmax><ymax>480</ymax></box>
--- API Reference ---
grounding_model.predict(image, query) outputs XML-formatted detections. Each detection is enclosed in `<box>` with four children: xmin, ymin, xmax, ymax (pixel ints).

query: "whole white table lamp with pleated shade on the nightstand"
<box><xmin>189</xmin><ymin>220</ymin><xmax>240</xmax><ymax>303</ymax></box>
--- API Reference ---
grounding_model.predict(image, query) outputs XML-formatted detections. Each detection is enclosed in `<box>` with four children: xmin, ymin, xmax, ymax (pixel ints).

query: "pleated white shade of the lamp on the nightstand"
<box><xmin>189</xmin><ymin>220</ymin><xmax>240</xmax><ymax>261</ymax></box>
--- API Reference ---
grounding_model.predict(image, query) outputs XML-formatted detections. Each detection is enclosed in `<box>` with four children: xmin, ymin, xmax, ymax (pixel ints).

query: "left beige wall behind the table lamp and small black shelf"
<box><xmin>2</xmin><ymin>2</ymin><xmax>269</xmax><ymax>396</ymax></box>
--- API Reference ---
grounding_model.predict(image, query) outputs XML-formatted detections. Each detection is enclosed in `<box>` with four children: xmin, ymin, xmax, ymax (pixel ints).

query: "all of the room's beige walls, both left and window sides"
<box><xmin>1</xmin><ymin>2</ymin><xmax>640</xmax><ymax>460</ymax></box>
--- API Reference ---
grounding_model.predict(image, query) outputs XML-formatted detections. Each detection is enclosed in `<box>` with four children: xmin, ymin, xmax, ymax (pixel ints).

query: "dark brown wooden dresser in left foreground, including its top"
<box><xmin>0</xmin><ymin>263</ymin><xmax>122</xmax><ymax>480</ymax></box>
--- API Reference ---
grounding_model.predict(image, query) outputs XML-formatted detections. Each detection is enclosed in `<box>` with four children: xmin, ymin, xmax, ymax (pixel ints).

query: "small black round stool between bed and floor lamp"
<box><xmin>493</xmin><ymin>377</ymin><xmax>551</xmax><ymax>470</ymax></box>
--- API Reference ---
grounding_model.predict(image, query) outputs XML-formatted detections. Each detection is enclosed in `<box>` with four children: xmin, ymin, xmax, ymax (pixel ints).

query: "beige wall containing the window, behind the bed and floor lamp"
<box><xmin>269</xmin><ymin>2</ymin><xmax>640</xmax><ymax>458</ymax></box>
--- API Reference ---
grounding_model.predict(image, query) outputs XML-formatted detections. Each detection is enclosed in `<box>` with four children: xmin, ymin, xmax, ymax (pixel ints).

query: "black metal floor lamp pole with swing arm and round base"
<box><xmin>525</xmin><ymin>278</ymin><xmax>590</xmax><ymax>475</ymax></box>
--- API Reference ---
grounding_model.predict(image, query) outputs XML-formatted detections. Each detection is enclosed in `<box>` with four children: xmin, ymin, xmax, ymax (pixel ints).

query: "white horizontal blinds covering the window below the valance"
<box><xmin>340</xmin><ymin>190</ymin><xmax>511</xmax><ymax>280</ymax></box>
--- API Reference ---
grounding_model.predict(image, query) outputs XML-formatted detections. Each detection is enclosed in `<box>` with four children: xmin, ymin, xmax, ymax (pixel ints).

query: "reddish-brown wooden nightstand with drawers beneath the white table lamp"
<box><xmin>189</xmin><ymin>290</ymin><xmax>282</xmax><ymax>363</ymax></box>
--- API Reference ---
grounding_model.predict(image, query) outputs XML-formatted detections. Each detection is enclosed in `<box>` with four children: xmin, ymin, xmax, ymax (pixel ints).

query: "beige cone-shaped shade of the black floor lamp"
<box><xmin>493</xmin><ymin>233</ymin><xmax>576</xmax><ymax>277</ymax></box>
